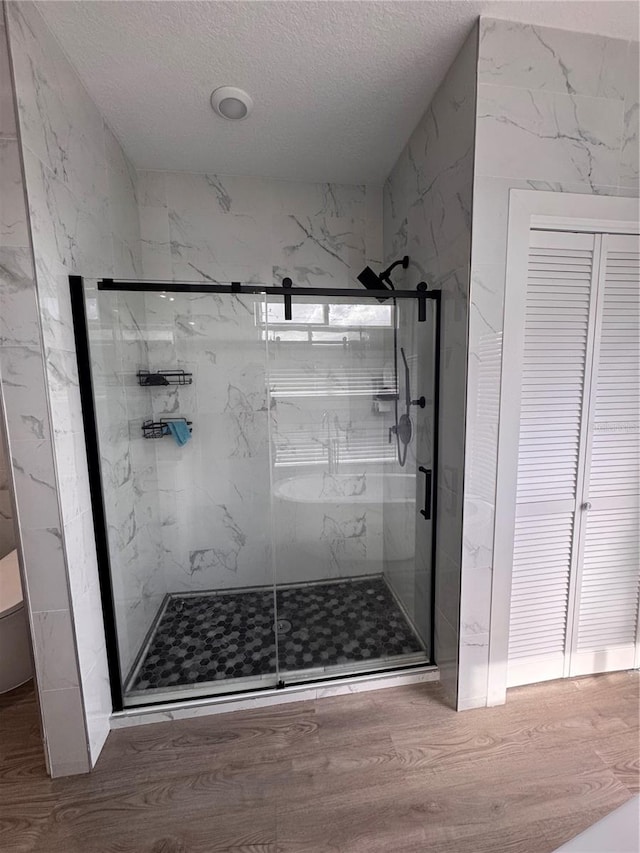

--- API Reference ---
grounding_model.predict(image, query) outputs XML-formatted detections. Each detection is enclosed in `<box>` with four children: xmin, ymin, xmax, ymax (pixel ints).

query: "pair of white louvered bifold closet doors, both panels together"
<box><xmin>507</xmin><ymin>230</ymin><xmax>638</xmax><ymax>686</ymax></box>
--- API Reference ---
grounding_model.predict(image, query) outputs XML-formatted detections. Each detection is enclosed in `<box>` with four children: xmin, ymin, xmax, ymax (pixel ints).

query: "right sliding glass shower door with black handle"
<box><xmin>263</xmin><ymin>290</ymin><xmax>434</xmax><ymax>683</ymax></box>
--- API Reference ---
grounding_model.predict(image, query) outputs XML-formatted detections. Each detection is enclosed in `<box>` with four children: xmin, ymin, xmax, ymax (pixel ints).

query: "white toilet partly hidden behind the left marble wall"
<box><xmin>0</xmin><ymin>551</ymin><xmax>32</xmax><ymax>693</ymax></box>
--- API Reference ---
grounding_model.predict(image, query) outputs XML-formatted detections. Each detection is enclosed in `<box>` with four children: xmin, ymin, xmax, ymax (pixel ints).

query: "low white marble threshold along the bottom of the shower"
<box><xmin>109</xmin><ymin>665</ymin><xmax>440</xmax><ymax>729</ymax></box>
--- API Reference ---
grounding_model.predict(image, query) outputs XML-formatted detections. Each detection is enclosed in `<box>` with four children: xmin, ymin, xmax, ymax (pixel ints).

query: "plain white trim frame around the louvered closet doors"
<box><xmin>487</xmin><ymin>189</ymin><xmax>640</xmax><ymax>705</ymax></box>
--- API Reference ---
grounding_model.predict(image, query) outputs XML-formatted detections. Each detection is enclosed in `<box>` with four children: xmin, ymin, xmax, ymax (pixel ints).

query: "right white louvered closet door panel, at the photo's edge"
<box><xmin>570</xmin><ymin>234</ymin><xmax>640</xmax><ymax>675</ymax></box>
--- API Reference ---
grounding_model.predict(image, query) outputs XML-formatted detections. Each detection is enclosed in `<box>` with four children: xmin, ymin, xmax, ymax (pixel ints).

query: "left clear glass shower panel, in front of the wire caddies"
<box><xmin>86</xmin><ymin>283</ymin><xmax>277</xmax><ymax>705</ymax></box>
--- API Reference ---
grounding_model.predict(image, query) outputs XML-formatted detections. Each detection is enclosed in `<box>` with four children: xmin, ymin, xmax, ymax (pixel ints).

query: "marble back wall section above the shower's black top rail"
<box><xmin>138</xmin><ymin>172</ymin><xmax>382</xmax><ymax>287</ymax></box>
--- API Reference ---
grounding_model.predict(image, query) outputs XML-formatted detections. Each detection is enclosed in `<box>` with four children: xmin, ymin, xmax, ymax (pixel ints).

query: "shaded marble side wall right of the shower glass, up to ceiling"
<box><xmin>384</xmin><ymin>27</ymin><xmax>477</xmax><ymax>702</ymax></box>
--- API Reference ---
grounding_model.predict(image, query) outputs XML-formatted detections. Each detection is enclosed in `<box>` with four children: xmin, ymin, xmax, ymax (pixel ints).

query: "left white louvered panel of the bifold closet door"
<box><xmin>507</xmin><ymin>231</ymin><xmax>598</xmax><ymax>687</ymax></box>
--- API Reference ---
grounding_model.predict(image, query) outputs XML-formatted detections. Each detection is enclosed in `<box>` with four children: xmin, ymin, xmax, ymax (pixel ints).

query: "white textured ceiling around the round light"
<box><xmin>37</xmin><ymin>0</ymin><xmax>638</xmax><ymax>183</ymax></box>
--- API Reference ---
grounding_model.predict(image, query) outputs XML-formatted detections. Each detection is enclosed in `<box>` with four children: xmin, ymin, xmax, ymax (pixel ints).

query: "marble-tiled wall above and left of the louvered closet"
<box><xmin>459</xmin><ymin>18</ymin><xmax>639</xmax><ymax>708</ymax></box>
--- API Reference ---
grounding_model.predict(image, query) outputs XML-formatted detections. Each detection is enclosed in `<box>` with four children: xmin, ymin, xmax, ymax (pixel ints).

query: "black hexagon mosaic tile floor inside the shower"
<box><xmin>131</xmin><ymin>578</ymin><xmax>422</xmax><ymax>691</ymax></box>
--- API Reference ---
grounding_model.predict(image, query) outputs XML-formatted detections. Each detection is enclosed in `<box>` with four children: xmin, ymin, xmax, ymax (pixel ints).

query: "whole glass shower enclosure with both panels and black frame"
<box><xmin>71</xmin><ymin>277</ymin><xmax>440</xmax><ymax>709</ymax></box>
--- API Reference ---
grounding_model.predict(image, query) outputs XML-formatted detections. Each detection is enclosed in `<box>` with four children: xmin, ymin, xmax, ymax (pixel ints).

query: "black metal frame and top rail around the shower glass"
<box><xmin>69</xmin><ymin>275</ymin><xmax>442</xmax><ymax>711</ymax></box>
